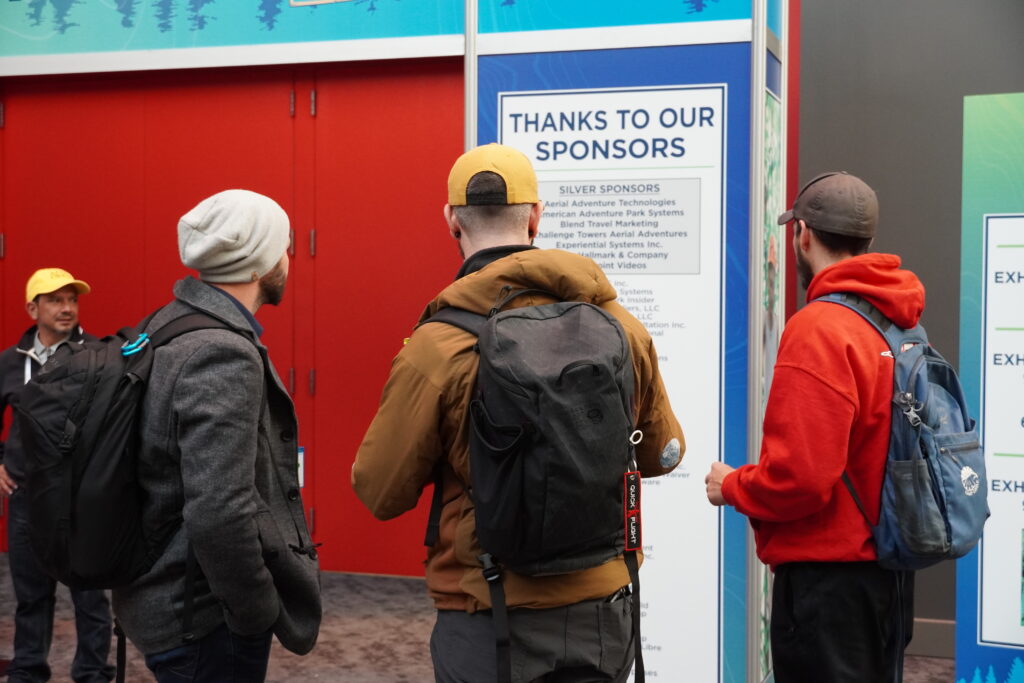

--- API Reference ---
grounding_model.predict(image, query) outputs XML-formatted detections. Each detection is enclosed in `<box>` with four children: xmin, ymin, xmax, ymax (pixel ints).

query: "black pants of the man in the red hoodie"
<box><xmin>771</xmin><ymin>562</ymin><xmax>913</xmax><ymax>683</ymax></box>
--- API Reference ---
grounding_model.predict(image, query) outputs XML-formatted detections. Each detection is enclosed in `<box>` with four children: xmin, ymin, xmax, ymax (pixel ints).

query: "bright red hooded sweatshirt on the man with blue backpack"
<box><xmin>722</xmin><ymin>254</ymin><xmax>925</xmax><ymax>567</ymax></box>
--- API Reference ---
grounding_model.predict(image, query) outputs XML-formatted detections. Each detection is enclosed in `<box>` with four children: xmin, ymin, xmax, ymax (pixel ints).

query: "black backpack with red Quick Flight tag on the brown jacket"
<box><xmin>425</xmin><ymin>287</ymin><xmax>644</xmax><ymax>682</ymax></box>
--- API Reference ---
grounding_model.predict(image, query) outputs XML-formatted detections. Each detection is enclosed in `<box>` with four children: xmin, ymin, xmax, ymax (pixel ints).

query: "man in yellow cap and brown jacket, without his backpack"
<box><xmin>352</xmin><ymin>144</ymin><xmax>684</xmax><ymax>683</ymax></box>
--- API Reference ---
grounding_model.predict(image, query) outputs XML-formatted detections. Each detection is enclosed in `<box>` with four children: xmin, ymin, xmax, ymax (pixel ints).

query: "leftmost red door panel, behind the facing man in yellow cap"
<box><xmin>0</xmin><ymin>79</ymin><xmax>144</xmax><ymax>346</ymax></box>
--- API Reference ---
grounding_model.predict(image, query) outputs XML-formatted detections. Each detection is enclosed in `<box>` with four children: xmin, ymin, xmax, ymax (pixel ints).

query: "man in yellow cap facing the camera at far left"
<box><xmin>0</xmin><ymin>268</ymin><xmax>114</xmax><ymax>683</ymax></box>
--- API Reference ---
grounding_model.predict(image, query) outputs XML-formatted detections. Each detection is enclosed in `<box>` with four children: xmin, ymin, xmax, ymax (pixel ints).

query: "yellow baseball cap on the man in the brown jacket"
<box><xmin>449</xmin><ymin>142</ymin><xmax>538</xmax><ymax>206</ymax></box>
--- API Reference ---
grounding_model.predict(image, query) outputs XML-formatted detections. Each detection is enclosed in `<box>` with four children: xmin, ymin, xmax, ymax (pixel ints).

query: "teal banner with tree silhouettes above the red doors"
<box><xmin>0</xmin><ymin>0</ymin><xmax>464</xmax><ymax>57</ymax></box>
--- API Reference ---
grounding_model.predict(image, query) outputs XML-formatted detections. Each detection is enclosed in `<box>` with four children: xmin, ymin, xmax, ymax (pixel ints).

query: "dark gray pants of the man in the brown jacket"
<box><xmin>430</xmin><ymin>596</ymin><xmax>633</xmax><ymax>683</ymax></box>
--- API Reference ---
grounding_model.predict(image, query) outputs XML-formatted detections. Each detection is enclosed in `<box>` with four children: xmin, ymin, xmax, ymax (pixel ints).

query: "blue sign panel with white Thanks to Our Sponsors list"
<box><xmin>477</xmin><ymin>42</ymin><xmax>751</xmax><ymax>683</ymax></box>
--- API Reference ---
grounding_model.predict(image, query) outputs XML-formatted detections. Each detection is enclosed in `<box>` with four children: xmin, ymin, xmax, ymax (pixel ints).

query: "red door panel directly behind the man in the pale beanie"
<box><xmin>138</xmin><ymin>70</ymin><xmax>305</xmax><ymax>374</ymax></box>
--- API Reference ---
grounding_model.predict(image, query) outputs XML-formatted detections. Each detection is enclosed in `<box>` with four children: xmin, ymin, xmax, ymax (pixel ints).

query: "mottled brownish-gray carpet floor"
<box><xmin>0</xmin><ymin>555</ymin><xmax>953</xmax><ymax>683</ymax></box>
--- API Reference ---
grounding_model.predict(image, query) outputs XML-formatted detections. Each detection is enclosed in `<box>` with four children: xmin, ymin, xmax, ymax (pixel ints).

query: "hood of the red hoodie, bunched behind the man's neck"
<box><xmin>807</xmin><ymin>253</ymin><xmax>925</xmax><ymax>329</ymax></box>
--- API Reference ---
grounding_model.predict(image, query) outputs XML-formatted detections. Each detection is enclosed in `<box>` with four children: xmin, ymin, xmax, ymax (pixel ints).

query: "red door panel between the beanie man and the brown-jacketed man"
<box><xmin>314</xmin><ymin>59</ymin><xmax>463</xmax><ymax>574</ymax></box>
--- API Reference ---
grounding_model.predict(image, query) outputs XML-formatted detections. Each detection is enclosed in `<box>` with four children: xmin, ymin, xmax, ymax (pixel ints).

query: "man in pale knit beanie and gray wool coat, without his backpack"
<box><xmin>114</xmin><ymin>189</ymin><xmax>321</xmax><ymax>683</ymax></box>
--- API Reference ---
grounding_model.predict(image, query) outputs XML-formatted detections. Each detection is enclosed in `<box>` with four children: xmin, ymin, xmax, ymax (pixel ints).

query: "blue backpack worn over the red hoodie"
<box><xmin>815</xmin><ymin>293</ymin><xmax>989</xmax><ymax>569</ymax></box>
